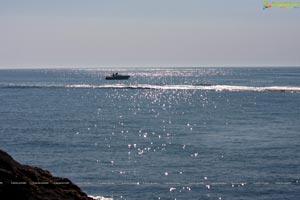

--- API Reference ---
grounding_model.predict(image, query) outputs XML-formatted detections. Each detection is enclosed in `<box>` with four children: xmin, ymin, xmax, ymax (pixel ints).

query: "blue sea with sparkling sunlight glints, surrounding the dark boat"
<box><xmin>0</xmin><ymin>68</ymin><xmax>300</xmax><ymax>200</ymax></box>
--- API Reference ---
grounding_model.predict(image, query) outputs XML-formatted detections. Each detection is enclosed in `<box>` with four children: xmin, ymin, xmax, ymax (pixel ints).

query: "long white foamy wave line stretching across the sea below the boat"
<box><xmin>0</xmin><ymin>84</ymin><xmax>300</xmax><ymax>92</ymax></box>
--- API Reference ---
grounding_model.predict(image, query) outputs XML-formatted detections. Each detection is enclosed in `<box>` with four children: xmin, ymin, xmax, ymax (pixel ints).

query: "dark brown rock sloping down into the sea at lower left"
<box><xmin>0</xmin><ymin>150</ymin><xmax>92</xmax><ymax>200</ymax></box>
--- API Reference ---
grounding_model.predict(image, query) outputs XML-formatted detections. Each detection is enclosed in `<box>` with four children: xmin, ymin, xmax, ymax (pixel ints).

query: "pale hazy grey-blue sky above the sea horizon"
<box><xmin>0</xmin><ymin>0</ymin><xmax>300</xmax><ymax>68</ymax></box>
